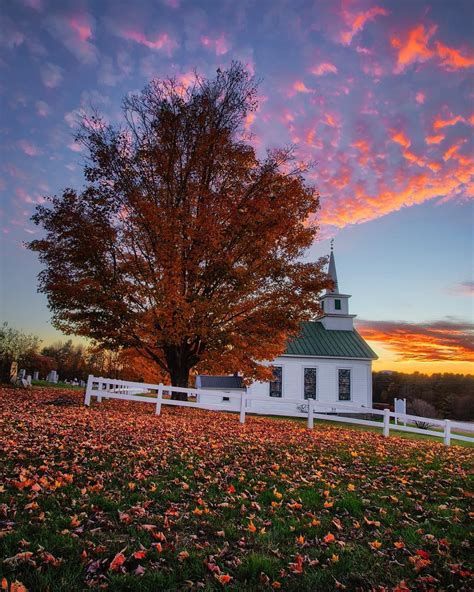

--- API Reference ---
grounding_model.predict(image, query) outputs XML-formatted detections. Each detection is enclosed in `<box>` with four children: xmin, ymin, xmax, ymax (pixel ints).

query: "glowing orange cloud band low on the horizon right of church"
<box><xmin>357</xmin><ymin>321</ymin><xmax>474</xmax><ymax>362</ymax></box>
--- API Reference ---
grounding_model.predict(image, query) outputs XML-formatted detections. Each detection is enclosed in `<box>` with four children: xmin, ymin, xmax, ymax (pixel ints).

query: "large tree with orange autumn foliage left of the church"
<box><xmin>29</xmin><ymin>63</ymin><xmax>327</xmax><ymax>394</ymax></box>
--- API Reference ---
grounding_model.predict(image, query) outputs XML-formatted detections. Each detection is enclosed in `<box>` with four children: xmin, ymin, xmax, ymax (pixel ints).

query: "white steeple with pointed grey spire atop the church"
<box><xmin>320</xmin><ymin>239</ymin><xmax>356</xmax><ymax>331</ymax></box>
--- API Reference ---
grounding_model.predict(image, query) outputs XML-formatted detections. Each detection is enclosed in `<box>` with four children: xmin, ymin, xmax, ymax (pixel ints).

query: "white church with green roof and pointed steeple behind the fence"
<box><xmin>196</xmin><ymin>247</ymin><xmax>377</xmax><ymax>411</ymax></box>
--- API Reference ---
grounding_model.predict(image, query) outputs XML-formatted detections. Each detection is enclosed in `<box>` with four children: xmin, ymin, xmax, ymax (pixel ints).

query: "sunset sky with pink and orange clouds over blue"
<box><xmin>0</xmin><ymin>0</ymin><xmax>474</xmax><ymax>373</ymax></box>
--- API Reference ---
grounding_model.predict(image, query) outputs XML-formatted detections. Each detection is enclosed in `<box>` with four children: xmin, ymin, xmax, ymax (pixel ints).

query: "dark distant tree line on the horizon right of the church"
<box><xmin>372</xmin><ymin>372</ymin><xmax>474</xmax><ymax>421</ymax></box>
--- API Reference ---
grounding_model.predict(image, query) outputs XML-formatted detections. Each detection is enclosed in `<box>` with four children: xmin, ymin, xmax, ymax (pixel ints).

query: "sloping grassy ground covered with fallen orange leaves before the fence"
<box><xmin>0</xmin><ymin>389</ymin><xmax>474</xmax><ymax>592</ymax></box>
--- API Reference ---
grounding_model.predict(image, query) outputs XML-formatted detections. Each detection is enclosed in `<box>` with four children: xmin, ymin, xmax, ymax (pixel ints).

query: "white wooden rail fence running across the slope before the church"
<box><xmin>84</xmin><ymin>375</ymin><xmax>474</xmax><ymax>446</ymax></box>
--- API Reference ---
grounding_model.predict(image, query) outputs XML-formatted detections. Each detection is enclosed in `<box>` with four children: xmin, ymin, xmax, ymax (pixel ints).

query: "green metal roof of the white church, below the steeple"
<box><xmin>285</xmin><ymin>321</ymin><xmax>377</xmax><ymax>360</ymax></box>
